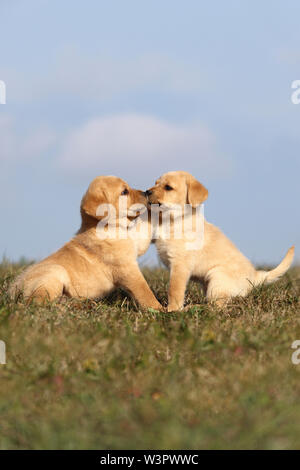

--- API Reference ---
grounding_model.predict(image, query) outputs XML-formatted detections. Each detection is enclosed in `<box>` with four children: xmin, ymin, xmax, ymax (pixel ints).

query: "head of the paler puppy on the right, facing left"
<box><xmin>146</xmin><ymin>171</ymin><xmax>208</xmax><ymax>207</ymax></box>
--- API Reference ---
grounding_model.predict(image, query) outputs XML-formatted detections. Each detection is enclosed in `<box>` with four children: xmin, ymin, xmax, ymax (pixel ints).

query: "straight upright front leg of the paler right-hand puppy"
<box><xmin>168</xmin><ymin>263</ymin><xmax>191</xmax><ymax>312</ymax></box>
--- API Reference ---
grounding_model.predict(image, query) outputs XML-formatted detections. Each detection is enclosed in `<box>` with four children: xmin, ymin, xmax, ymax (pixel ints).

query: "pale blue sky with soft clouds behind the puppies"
<box><xmin>0</xmin><ymin>0</ymin><xmax>300</xmax><ymax>263</ymax></box>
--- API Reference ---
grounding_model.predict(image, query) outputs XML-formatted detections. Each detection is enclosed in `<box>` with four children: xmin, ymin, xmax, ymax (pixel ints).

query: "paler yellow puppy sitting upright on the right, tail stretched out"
<box><xmin>146</xmin><ymin>171</ymin><xmax>294</xmax><ymax>312</ymax></box>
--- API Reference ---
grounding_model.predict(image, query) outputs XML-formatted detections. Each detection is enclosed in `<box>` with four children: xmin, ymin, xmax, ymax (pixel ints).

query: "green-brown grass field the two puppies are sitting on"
<box><xmin>0</xmin><ymin>262</ymin><xmax>300</xmax><ymax>449</ymax></box>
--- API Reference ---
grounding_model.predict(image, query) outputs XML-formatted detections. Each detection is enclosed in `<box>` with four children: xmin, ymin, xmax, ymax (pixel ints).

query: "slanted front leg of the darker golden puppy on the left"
<box><xmin>118</xmin><ymin>265</ymin><xmax>163</xmax><ymax>311</ymax></box>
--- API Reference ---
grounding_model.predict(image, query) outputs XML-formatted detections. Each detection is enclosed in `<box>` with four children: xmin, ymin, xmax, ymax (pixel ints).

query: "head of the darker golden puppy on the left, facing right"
<box><xmin>80</xmin><ymin>176</ymin><xmax>147</xmax><ymax>220</ymax></box>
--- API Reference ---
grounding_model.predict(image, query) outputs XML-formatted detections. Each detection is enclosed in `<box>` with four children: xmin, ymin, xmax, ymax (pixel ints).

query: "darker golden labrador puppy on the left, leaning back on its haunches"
<box><xmin>10</xmin><ymin>176</ymin><xmax>162</xmax><ymax>310</ymax></box>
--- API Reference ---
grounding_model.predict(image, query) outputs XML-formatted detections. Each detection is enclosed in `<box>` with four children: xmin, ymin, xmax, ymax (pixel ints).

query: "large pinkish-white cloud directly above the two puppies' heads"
<box><xmin>58</xmin><ymin>114</ymin><xmax>231</xmax><ymax>183</ymax></box>
